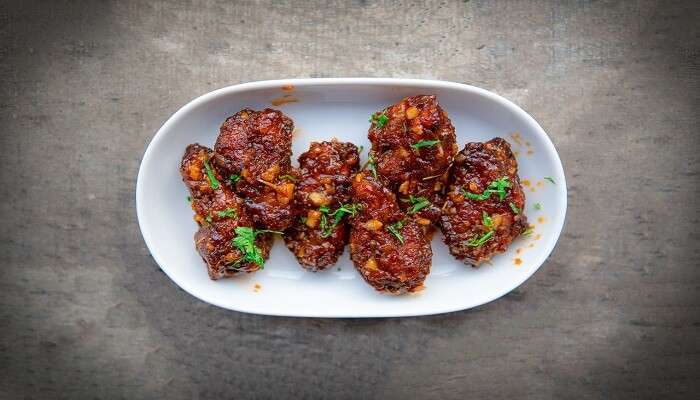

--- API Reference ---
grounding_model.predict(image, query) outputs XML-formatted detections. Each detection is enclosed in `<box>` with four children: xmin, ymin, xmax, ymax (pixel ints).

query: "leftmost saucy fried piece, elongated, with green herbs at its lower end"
<box><xmin>180</xmin><ymin>144</ymin><xmax>272</xmax><ymax>280</ymax></box>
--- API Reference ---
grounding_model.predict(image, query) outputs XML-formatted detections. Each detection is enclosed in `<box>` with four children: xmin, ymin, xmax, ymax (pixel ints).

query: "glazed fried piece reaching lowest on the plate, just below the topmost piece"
<box><xmin>350</xmin><ymin>171</ymin><xmax>432</xmax><ymax>294</ymax></box>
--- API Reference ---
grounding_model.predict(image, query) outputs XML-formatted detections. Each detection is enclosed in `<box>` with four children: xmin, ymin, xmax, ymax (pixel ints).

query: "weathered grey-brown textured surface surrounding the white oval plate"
<box><xmin>0</xmin><ymin>0</ymin><xmax>700</xmax><ymax>399</ymax></box>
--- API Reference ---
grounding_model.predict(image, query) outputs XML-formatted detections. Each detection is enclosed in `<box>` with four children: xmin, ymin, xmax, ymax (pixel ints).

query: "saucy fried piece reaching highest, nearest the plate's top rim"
<box><xmin>369</xmin><ymin>95</ymin><xmax>459</xmax><ymax>224</ymax></box>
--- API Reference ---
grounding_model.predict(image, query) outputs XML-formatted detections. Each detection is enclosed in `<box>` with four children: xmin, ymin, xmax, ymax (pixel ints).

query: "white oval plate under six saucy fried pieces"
<box><xmin>136</xmin><ymin>78</ymin><xmax>566</xmax><ymax>317</ymax></box>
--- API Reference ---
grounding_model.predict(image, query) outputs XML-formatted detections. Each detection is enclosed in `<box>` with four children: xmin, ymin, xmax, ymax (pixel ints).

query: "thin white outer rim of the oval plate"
<box><xmin>135</xmin><ymin>78</ymin><xmax>568</xmax><ymax>318</ymax></box>
